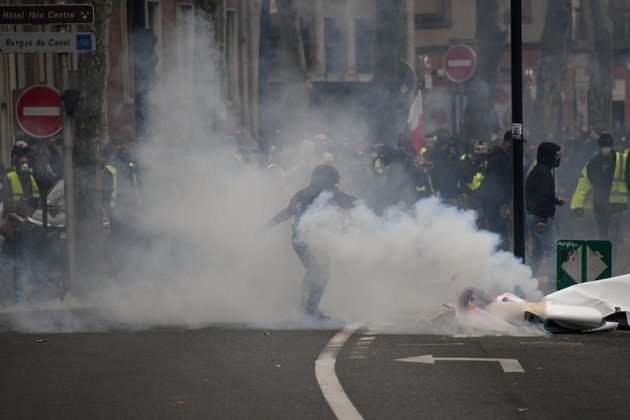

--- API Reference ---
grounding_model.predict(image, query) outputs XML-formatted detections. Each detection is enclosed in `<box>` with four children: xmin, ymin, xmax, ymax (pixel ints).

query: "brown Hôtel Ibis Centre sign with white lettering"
<box><xmin>0</xmin><ymin>4</ymin><xmax>94</xmax><ymax>25</ymax></box>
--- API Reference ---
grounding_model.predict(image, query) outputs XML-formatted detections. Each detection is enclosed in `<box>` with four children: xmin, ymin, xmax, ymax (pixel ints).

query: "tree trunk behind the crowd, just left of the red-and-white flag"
<box><xmin>370</xmin><ymin>0</ymin><xmax>407</xmax><ymax>145</ymax></box>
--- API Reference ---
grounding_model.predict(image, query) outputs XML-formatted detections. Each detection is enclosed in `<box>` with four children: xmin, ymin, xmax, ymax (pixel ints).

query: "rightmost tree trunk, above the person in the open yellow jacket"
<box><xmin>582</xmin><ymin>0</ymin><xmax>614</xmax><ymax>132</ymax></box>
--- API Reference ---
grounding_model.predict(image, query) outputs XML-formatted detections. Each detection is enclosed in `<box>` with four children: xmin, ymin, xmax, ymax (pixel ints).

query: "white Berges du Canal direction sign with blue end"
<box><xmin>0</xmin><ymin>32</ymin><xmax>96</xmax><ymax>53</ymax></box>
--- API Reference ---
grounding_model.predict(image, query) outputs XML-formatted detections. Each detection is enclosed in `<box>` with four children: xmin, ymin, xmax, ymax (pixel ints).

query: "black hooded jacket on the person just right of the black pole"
<box><xmin>525</xmin><ymin>142</ymin><xmax>560</xmax><ymax>219</ymax></box>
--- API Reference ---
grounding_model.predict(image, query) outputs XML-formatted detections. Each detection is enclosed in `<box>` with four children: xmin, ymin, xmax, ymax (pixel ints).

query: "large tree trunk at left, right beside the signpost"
<box><xmin>73</xmin><ymin>0</ymin><xmax>113</xmax><ymax>287</ymax></box>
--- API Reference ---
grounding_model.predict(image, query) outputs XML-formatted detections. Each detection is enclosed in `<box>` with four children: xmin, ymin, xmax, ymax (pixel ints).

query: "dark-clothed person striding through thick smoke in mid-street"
<box><xmin>259</xmin><ymin>164</ymin><xmax>357</xmax><ymax>322</ymax></box>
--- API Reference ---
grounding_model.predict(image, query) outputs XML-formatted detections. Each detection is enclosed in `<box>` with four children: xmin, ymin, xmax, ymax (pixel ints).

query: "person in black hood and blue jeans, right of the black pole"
<box><xmin>525</xmin><ymin>142</ymin><xmax>566</xmax><ymax>291</ymax></box>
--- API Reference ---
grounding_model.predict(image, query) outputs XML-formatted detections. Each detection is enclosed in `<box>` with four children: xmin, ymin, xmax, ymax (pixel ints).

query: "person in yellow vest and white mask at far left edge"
<box><xmin>2</xmin><ymin>156</ymin><xmax>39</xmax><ymax>303</ymax></box>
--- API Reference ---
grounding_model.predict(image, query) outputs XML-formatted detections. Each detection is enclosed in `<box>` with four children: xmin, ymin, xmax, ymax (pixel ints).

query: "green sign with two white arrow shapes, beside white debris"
<box><xmin>556</xmin><ymin>240</ymin><xmax>612</xmax><ymax>290</ymax></box>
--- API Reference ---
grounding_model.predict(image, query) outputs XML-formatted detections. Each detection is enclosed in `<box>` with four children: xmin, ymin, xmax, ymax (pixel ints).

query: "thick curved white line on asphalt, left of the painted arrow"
<box><xmin>315</xmin><ymin>322</ymin><xmax>363</xmax><ymax>420</ymax></box>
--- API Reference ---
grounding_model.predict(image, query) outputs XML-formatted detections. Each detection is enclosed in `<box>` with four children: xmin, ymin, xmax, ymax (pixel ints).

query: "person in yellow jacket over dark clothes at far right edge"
<box><xmin>571</xmin><ymin>132</ymin><xmax>630</xmax><ymax>258</ymax></box>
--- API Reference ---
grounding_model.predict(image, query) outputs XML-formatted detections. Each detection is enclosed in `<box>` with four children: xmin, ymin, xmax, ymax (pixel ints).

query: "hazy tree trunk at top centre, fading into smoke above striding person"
<box><xmin>276</xmin><ymin>0</ymin><xmax>311</xmax><ymax>138</ymax></box>
